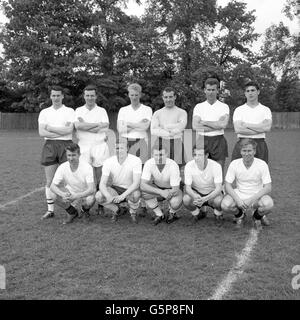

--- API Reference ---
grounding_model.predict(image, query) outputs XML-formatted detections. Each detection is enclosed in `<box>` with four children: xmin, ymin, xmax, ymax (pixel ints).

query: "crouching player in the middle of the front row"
<box><xmin>141</xmin><ymin>139</ymin><xmax>182</xmax><ymax>225</ymax></box>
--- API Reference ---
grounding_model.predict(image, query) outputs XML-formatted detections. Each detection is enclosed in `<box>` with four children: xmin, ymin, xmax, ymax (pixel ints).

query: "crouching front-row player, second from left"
<box><xmin>96</xmin><ymin>138</ymin><xmax>142</xmax><ymax>223</ymax></box>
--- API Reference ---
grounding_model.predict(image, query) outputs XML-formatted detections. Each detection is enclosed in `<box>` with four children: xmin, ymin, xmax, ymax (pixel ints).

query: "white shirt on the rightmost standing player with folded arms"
<box><xmin>233</xmin><ymin>103</ymin><xmax>272</xmax><ymax>139</ymax></box>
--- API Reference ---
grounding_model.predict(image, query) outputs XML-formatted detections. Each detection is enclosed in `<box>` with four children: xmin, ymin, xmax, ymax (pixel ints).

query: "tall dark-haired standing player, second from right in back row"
<box><xmin>192</xmin><ymin>78</ymin><xmax>229</xmax><ymax>171</ymax></box>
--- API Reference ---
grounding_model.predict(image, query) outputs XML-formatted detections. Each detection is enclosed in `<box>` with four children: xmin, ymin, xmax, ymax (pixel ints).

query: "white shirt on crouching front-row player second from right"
<box><xmin>184</xmin><ymin>159</ymin><xmax>223</xmax><ymax>194</ymax></box>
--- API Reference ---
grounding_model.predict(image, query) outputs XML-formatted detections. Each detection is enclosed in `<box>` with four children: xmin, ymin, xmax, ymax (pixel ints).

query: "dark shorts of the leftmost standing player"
<box><xmin>41</xmin><ymin>140</ymin><xmax>72</xmax><ymax>167</ymax></box>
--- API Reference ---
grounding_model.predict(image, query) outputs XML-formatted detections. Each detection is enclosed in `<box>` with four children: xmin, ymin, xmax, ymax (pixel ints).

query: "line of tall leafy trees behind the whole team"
<box><xmin>0</xmin><ymin>0</ymin><xmax>300</xmax><ymax>112</ymax></box>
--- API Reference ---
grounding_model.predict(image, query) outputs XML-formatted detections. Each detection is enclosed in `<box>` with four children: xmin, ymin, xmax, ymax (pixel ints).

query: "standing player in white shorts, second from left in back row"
<box><xmin>74</xmin><ymin>85</ymin><xmax>109</xmax><ymax>185</ymax></box>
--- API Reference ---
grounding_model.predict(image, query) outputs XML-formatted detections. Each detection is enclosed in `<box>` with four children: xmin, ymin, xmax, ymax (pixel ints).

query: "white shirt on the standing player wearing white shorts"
<box><xmin>75</xmin><ymin>105</ymin><xmax>109</xmax><ymax>144</ymax></box>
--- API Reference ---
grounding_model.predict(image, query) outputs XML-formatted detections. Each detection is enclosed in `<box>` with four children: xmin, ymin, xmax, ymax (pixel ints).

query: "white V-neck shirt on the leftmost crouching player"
<box><xmin>53</xmin><ymin>160</ymin><xmax>94</xmax><ymax>192</ymax></box>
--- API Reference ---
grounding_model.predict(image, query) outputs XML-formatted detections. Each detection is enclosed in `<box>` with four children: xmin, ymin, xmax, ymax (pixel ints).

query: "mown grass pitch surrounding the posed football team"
<box><xmin>0</xmin><ymin>130</ymin><xmax>300</xmax><ymax>300</ymax></box>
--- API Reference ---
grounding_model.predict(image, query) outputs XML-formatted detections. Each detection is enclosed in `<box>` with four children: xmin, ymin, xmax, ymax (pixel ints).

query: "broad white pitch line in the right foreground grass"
<box><xmin>208</xmin><ymin>229</ymin><xmax>258</xmax><ymax>300</ymax></box>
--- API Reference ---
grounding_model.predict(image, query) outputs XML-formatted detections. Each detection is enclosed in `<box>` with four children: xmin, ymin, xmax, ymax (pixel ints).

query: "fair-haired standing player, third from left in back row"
<box><xmin>117</xmin><ymin>83</ymin><xmax>152</xmax><ymax>163</ymax></box>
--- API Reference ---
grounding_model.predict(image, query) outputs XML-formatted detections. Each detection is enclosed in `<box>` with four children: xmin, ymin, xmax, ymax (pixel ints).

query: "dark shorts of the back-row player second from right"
<box><xmin>196</xmin><ymin>135</ymin><xmax>228</xmax><ymax>161</ymax></box>
